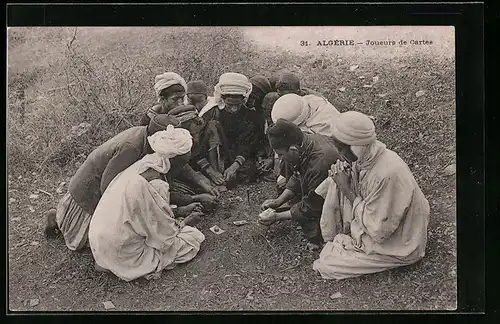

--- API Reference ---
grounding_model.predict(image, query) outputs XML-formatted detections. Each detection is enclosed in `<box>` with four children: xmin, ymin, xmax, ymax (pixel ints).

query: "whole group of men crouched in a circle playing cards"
<box><xmin>45</xmin><ymin>72</ymin><xmax>429</xmax><ymax>281</ymax></box>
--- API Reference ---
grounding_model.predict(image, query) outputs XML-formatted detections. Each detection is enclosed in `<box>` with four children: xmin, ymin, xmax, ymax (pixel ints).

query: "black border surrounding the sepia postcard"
<box><xmin>4</xmin><ymin>3</ymin><xmax>493</xmax><ymax>321</ymax></box>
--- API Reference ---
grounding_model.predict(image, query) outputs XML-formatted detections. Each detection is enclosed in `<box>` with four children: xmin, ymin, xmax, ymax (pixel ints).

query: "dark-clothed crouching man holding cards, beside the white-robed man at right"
<box><xmin>259</xmin><ymin>119</ymin><xmax>340</xmax><ymax>249</ymax></box>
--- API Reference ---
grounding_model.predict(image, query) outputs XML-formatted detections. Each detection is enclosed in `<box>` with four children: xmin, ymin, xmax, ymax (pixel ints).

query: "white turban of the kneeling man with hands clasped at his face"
<box><xmin>332</xmin><ymin>111</ymin><xmax>377</xmax><ymax>145</ymax></box>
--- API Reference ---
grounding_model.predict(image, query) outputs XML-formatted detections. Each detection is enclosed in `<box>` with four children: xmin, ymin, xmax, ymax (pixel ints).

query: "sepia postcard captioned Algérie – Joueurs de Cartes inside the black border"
<box><xmin>7</xmin><ymin>26</ymin><xmax>457</xmax><ymax>312</ymax></box>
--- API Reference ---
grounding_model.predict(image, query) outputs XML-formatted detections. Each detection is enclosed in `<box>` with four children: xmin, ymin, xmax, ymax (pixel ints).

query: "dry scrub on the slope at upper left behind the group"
<box><xmin>8</xmin><ymin>28</ymin><xmax>266</xmax><ymax>170</ymax></box>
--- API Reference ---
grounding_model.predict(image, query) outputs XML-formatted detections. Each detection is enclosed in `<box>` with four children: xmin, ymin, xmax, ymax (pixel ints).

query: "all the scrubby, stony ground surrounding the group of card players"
<box><xmin>7</xmin><ymin>27</ymin><xmax>456</xmax><ymax>311</ymax></box>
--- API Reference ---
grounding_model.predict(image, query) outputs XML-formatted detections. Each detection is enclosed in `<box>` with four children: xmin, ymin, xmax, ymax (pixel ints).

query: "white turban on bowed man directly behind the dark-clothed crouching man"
<box><xmin>271</xmin><ymin>93</ymin><xmax>310</xmax><ymax>126</ymax></box>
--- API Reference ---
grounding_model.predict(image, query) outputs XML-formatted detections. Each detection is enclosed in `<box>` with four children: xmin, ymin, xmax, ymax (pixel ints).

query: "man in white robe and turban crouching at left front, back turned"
<box><xmin>89</xmin><ymin>125</ymin><xmax>205</xmax><ymax>281</ymax></box>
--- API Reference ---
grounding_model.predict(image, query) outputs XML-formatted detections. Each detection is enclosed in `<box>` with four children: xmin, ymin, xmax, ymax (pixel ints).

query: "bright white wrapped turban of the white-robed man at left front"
<box><xmin>148</xmin><ymin>125</ymin><xmax>193</xmax><ymax>159</ymax></box>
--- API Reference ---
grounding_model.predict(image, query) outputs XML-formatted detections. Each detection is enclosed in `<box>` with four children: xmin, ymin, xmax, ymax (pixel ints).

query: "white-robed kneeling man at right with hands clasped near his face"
<box><xmin>313</xmin><ymin>111</ymin><xmax>429</xmax><ymax>279</ymax></box>
